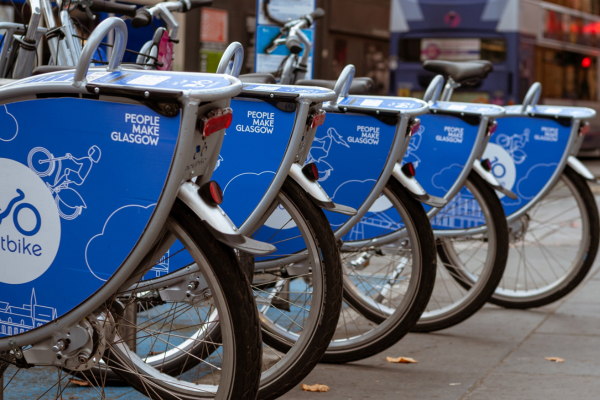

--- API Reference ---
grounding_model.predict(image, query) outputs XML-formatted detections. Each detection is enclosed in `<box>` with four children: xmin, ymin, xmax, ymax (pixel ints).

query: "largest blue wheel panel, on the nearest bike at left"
<box><xmin>0</xmin><ymin>98</ymin><xmax>180</xmax><ymax>336</ymax></box>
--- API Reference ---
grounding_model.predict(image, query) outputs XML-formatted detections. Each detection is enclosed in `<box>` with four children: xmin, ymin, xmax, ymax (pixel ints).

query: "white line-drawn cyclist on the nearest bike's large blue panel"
<box><xmin>27</xmin><ymin>145</ymin><xmax>102</xmax><ymax>220</ymax></box>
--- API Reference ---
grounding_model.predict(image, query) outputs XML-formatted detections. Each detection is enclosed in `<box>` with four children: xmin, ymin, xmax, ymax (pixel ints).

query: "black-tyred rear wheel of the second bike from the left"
<box><xmin>252</xmin><ymin>178</ymin><xmax>342</xmax><ymax>399</ymax></box>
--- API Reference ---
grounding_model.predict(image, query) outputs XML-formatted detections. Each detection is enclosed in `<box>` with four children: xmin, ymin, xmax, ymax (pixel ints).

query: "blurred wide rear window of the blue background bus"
<box><xmin>398</xmin><ymin>38</ymin><xmax>506</xmax><ymax>64</ymax></box>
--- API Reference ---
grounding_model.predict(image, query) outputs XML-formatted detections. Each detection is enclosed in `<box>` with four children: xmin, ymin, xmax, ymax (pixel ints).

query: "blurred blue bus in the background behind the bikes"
<box><xmin>389</xmin><ymin>0</ymin><xmax>600</xmax><ymax>155</ymax></box>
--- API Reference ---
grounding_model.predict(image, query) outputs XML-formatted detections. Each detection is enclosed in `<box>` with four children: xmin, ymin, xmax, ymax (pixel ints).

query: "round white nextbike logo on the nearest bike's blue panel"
<box><xmin>0</xmin><ymin>158</ymin><xmax>61</xmax><ymax>284</ymax></box>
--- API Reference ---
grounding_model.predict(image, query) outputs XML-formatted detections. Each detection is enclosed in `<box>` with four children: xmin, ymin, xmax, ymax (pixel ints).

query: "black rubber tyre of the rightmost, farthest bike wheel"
<box><xmin>490</xmin><ymin>166</ymin><xmax>600</xmax><ymax>309</ymax></box>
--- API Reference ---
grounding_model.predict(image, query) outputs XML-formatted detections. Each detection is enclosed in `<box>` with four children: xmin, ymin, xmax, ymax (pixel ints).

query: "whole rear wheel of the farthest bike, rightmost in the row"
<box><xmin>491</xmin><ymin>166</ymin><xmax>600</xmax><ymax>308</ymax></box>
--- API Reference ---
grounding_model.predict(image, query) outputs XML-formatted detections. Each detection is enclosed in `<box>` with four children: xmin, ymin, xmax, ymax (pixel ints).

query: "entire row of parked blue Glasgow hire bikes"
<box><xmin>0</xmin><ymin>0</ymin><xmax>600</xmax><ymax>399</ymax></box>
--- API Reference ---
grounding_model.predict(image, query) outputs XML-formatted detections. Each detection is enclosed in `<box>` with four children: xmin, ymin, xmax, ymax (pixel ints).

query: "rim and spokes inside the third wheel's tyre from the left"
<box><xmin>329</xmin><ymin>187</ymin><xmax>422</xmax><ymax>352</ymax></box>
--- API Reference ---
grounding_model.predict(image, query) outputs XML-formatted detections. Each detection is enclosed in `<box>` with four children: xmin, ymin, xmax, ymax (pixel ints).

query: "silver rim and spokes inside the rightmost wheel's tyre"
<box><xmin>494</xmin><ymin>173</ymin><xmax>591</xmax><ymax>302</ymax></box>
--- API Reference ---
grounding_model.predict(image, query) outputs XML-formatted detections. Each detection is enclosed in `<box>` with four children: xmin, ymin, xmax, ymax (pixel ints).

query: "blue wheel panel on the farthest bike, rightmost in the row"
<box><xmin>483</xmin><ymin>117</ymin><xmax>571</xmax><ymax>215</ymax></box>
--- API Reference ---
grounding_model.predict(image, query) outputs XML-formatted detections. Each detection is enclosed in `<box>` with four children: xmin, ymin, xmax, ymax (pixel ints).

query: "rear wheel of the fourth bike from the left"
<box><xmin>414</xmin><ymin>171</ymin><xmax>508</xmax><ymax>332</ymax></box>
